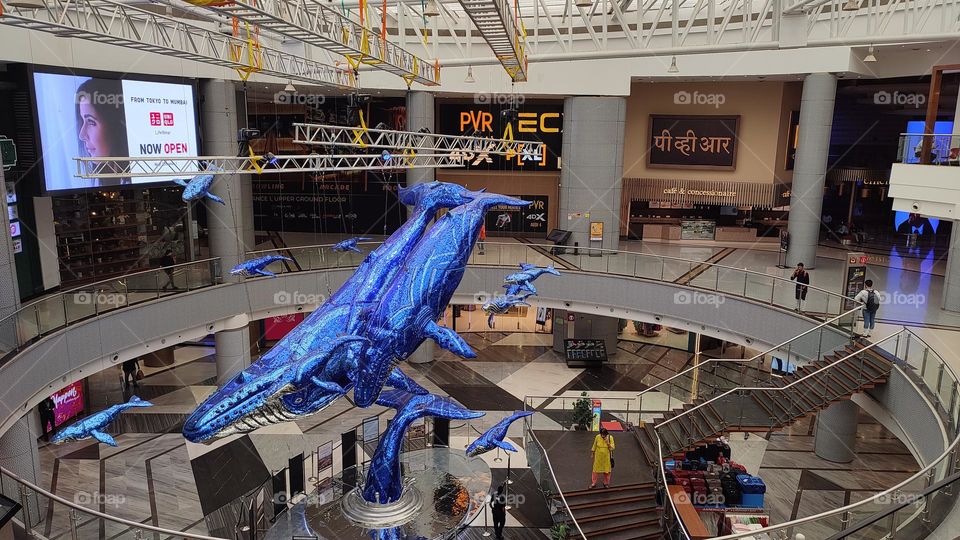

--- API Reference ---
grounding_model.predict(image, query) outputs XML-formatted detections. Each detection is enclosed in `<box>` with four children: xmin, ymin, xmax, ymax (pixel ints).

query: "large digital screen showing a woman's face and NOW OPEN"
<box><xmin>33</xmin><ymin>73</ymin><xmax>199</xmax><ymax>191</ymax></box>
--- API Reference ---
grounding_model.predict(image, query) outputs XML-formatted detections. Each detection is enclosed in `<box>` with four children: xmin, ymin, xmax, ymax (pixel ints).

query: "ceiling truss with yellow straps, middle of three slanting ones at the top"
<box><xmin>185</xmin><ymin>0</ymin><xmax>440</xmax><ymax>86</ymax></box>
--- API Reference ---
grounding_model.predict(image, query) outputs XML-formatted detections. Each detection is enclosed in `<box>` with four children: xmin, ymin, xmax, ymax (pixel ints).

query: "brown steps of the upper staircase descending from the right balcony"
<box><xmin>632</xmin><ymin>343</ymin><xmax>894</xmax><ymax>464</ymax></box>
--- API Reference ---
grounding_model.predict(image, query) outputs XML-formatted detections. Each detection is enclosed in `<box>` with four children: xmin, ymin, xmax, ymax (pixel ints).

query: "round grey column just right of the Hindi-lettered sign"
<box><xmin>787</xmin><ymin>73</ymin><xmax>837</xmax><ymax>268</ymax></box>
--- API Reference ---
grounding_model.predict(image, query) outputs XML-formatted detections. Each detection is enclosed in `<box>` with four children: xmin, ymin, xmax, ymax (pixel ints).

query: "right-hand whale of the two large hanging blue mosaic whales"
<box><xmin>353</xmin><ymin>193</ymin><xmax>530</xmax><ymax>407</ymax></box>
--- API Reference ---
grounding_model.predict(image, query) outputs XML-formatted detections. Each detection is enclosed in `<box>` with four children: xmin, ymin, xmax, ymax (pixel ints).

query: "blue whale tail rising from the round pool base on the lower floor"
<box><xmin>363</xmin><ymin>390</ymin><xmax>484</xmax><ymax>504</ymax></box>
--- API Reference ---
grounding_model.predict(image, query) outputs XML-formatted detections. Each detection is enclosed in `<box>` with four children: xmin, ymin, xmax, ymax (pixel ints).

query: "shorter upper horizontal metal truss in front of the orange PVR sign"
<box><xmin>293</xmin><ymin>124</ymin><xmax>543</xmax><ymax>156</ymax></box>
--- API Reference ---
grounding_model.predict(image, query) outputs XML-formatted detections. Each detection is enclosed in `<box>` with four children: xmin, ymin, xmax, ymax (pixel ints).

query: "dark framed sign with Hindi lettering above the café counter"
<box><xmin>647</xmin><ymin>114</ymin><xmax>740</xmax><ymax>170</ymax></box>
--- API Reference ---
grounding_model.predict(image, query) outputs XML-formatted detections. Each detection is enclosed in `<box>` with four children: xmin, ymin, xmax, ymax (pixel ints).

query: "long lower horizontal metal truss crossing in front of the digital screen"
<box><xmin>75</xmin><ymin>152</ymin><xmax>466</xmax><ymax>179</ymax></box>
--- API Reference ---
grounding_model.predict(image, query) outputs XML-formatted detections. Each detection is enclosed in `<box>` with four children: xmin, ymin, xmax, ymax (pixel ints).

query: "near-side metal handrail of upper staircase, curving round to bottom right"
<box><xmin>654</xmin><ymin>327</ymin><xmax>960</xmax><ymax>540</ymax></box>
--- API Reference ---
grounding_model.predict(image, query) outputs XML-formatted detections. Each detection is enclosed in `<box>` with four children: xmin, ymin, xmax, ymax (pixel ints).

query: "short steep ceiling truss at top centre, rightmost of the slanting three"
<box><xmin>460</xmin><ymin>0</ymin><xmax>527</xmax><ymax>82</ymax></box>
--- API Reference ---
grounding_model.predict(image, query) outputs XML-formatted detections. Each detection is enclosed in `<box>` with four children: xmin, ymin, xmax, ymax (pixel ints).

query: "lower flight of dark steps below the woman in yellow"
<box><xmin>563</xmin><ymin>482</ymin><xmax>663</xmax><ymax>540</ymax></box>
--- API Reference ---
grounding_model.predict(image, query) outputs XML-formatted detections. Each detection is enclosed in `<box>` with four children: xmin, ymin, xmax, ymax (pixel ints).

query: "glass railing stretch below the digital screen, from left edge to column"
<box><xmin>0</xmin><ymin>259</ymin><xmax>220</xmax><ymax>358</ymax></box>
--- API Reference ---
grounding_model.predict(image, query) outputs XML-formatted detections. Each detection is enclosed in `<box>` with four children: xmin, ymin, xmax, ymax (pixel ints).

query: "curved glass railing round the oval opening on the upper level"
<box><xmin>0</xmin><ymin>242</ymin><xmax>849</xmax><ymax>540</ymax></box>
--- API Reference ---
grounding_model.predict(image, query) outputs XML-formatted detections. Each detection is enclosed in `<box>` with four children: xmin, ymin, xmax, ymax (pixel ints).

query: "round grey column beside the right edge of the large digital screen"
<box><xmin>201</xmin><ymin>79</ymin><xmax>254</xmax><ymax>384</ymax></box>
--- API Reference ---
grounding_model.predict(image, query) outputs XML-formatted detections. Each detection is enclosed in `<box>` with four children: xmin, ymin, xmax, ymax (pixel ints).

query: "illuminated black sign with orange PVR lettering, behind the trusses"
<box><xmin>437</xmin><ymin>103</ymin><xmax>563</xmax><ymax>171</ymax></box>
